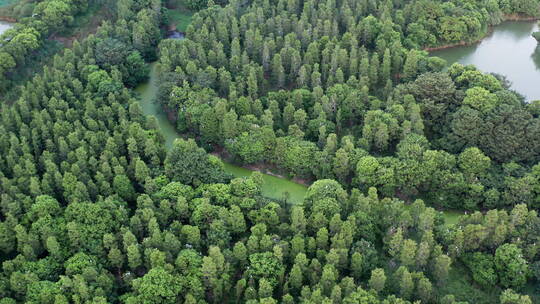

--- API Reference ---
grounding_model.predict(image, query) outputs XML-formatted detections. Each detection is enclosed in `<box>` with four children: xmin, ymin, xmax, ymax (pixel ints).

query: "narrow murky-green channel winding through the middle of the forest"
<box><xmin>135</xmin><ymin>64</ymin><xmax>307</xmax><ymax>204</ymax></box>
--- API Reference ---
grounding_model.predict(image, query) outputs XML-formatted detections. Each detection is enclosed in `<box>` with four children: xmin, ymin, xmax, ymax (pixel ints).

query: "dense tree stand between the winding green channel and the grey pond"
<box><xmin>158</xmin><ymin>1</ymin><xmax>540</xmax><ymax>210</ymax></box>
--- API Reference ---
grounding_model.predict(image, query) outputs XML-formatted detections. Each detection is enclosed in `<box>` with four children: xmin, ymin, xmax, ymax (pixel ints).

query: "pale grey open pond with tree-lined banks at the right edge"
<box><xmin>431</xmin><ymin>21</ymin><xmax>540</xmax><ymax>100</ymax></box>
